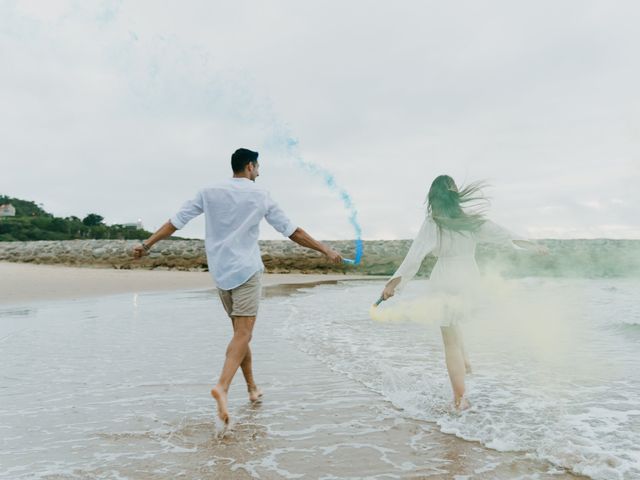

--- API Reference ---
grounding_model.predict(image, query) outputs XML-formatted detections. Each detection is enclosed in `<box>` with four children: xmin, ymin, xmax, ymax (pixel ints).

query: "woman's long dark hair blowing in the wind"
<box><xmin>427</xmin><ymin>175</ymin><xmax>488</xmax><ymax>233</ymax></box>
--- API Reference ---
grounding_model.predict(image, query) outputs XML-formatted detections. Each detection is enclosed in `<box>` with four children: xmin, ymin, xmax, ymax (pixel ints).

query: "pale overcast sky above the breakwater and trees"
<box><xmin>0</xmin><ymin>0</ymin><xmax>640</xmax><ymax>239</ymax></box>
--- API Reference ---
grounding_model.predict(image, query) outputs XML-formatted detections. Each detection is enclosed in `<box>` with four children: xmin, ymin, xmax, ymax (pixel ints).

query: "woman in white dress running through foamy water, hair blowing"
<box><xmin>382</xmin><ymin>175</ymin><xmax>546</xmax><ymax>410</ymax></box>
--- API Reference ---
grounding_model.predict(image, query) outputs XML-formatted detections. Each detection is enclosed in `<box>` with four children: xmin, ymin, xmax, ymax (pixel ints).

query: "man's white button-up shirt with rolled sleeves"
<box><xmin>170</xmin><ymin>178</ymin><xmax>296</xmax><ymax>290</ymax></box>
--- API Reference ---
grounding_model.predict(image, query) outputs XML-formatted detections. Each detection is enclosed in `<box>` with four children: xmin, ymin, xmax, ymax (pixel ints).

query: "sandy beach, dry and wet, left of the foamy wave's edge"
<box><xmin>0</xmin><ymin>264</ymin><xmax>580</xmax><ymax>480</ymax></box>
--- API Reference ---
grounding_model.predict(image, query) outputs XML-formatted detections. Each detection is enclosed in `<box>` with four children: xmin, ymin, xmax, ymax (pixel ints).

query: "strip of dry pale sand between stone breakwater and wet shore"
<box><xmin>0</xmin><ymin>262</ymin><xmax>383</xmax><ymax>305</ymax></box>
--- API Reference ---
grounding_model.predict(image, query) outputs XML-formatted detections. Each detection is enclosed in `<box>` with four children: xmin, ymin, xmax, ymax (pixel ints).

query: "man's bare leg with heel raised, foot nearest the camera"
<box><xmin>211</xmin><ymin>317</ymin><xmax>256</xmax><ymax>423</ymax></box>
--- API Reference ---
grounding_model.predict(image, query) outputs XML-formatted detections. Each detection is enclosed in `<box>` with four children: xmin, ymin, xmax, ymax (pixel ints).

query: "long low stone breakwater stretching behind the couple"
<box><xmin>0</xmin><ymin>239</ymin><xmax>640</xmax><ymax>277</ymax></box>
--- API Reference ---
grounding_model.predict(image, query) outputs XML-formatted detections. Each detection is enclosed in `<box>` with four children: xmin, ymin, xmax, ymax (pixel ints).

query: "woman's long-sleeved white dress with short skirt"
<box><xmin>391</xmin><ymin>215</ymin><xmax>522</xmax><ymax>326</ymax></box>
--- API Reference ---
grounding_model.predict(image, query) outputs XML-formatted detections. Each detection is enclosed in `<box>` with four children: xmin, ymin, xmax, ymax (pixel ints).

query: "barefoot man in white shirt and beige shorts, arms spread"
<box><xmin>133</xmin><ymin>148</ymin><xmax>342</xmax><ymax>424</ymax></box>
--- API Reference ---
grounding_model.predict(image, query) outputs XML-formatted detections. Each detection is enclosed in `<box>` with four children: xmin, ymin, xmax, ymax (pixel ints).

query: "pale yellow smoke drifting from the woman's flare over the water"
<box><xmin>369</xmin><ymin>274</ymin><xmax>601</xmax><ymax>373</ymax></box>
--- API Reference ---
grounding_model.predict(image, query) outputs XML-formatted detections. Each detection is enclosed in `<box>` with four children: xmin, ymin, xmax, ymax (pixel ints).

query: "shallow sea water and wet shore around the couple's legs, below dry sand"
<box><xmin>0</xmin><ymin>277</ymin><xmax>640</xmax><ymax>480</ymax></box>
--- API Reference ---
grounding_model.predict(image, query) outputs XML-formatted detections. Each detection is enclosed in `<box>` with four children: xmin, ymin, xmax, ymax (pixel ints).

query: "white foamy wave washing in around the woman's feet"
<box><xmin>286</xmin><ymin>282</ymin><xmax>640</xmax><ymax>480</ymax></box>
